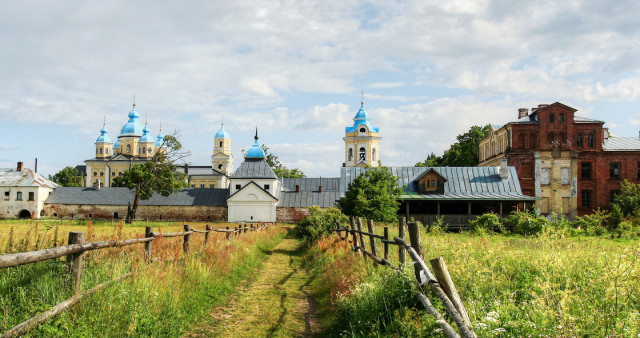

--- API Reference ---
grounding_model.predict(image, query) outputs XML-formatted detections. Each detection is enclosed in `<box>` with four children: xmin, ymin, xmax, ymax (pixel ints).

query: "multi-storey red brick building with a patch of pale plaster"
<box><xmin>478</xmin><ymin>102</ymin><xmax>640</xmax><ymax>216</ymax></box>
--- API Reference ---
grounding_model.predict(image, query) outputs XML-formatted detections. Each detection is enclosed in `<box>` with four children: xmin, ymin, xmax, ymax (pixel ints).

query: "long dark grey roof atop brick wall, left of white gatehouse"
<box><xmin>45</xmin><ymin>187</ymin><xmax>229</xmax><ymax>206</ymax></box>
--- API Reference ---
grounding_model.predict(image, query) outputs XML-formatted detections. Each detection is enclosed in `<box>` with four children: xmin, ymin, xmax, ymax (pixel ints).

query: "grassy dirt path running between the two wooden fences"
<box><xmin>187</xmin><ymin>238</ymin><xmax>318</xmax><ymax>337</ymax></box>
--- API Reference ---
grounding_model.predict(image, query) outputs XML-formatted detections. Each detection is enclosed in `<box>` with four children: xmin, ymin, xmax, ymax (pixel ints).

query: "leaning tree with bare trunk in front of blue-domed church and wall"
<box><xmin>114</xmin><ymin>133</ymin><xmax>189</xmax><ymax>223</ymax></box>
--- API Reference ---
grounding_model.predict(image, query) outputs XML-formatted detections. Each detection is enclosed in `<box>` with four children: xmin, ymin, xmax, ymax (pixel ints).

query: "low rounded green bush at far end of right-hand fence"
<box><xmin>295</xmin><ymin>206</ymin><xmax>349</xmax><ymax>243</ymax></box>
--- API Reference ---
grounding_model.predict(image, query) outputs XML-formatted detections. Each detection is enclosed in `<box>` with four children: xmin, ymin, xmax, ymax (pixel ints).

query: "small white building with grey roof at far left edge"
<box><xmin>0</xmin><ymin>162</ymin><xmax>59</xmax><ymax>218</ymax></box>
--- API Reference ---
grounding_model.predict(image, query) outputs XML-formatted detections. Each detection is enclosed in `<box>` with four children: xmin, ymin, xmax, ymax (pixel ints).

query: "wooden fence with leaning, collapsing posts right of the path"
<box><xmin>335</xmin><ymin>217</ymin><xmax>476</xmax><ymax>338</ymax></box>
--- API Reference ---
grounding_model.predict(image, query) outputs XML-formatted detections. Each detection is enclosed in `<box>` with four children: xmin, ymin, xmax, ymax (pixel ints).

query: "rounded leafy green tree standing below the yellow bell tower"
<box><xmin>338</xmin><ymin>167</ymin><xmax>402</xmax><ymax>223</ymax></box>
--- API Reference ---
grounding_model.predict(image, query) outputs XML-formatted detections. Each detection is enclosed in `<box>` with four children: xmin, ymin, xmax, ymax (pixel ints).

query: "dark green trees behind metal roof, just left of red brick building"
<box><xmin>416</xmin><ymin>124</ymin><xmax>491</xmax><ymax>167</ymax></box>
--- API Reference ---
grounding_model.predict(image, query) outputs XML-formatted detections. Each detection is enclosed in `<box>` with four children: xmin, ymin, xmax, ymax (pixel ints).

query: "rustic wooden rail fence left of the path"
<box><xmin>0</xmin><ymin>223</ymin><xmax>268</xmax><ymax>338</ymax></box>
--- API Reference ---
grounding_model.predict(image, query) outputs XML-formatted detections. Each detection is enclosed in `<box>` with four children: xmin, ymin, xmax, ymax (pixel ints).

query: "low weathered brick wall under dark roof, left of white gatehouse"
<box><xmin>44</xmin><ymin>204</ymin><xmax>227</xmax><ymax>222</ymax></box>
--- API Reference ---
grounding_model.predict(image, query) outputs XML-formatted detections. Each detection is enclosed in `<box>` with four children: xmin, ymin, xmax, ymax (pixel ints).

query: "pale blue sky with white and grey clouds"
<box><xmin>0</xmin><ymin>0</ymin><xmax>640</xmax><ymax>177</ymax></box>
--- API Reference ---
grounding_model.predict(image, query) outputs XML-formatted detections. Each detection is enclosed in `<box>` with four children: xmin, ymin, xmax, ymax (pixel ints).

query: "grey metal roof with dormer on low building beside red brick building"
<box><xmin>340</xmin><ymin>167</ymin><xmax>535</xmax><ymax>200</ymax></box>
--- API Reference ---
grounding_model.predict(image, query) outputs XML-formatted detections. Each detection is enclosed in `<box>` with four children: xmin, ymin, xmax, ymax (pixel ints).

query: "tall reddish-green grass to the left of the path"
<box><xmin>0</xmin><ymin>224</ymin><xmax>284</xmax><ymax>336</ymax></box>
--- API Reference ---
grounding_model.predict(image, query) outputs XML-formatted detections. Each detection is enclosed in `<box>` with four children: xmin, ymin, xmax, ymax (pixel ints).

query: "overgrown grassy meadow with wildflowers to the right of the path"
<box><xmin>308</xmin><ymin>227</ymin><xmax>640</xmax><ymax>337</ymax></box>
